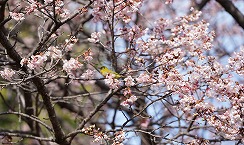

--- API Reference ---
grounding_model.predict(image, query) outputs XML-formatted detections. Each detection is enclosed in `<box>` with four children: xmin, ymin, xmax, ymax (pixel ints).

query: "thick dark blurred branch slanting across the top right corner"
<box><xmin>216</xmin><ymin>0</ymin><xmax>244</xmax><ymax>29</ymax></box>
